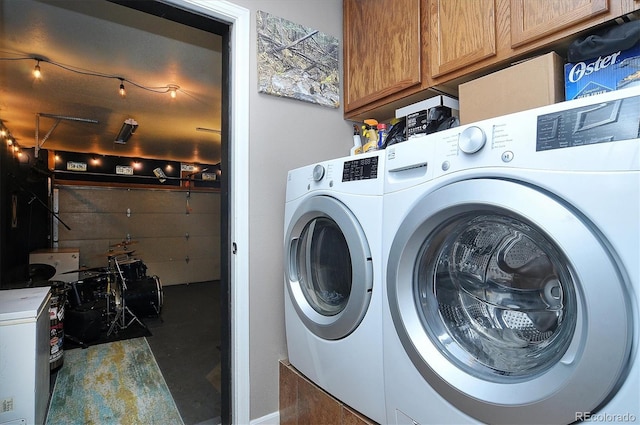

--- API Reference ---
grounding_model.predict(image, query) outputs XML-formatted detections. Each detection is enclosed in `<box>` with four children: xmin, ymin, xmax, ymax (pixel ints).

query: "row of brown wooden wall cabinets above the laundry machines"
<box><xmin>343</xmin><ymin>0</ymin><xmax>640</xmax><ymax>119</ymax></box>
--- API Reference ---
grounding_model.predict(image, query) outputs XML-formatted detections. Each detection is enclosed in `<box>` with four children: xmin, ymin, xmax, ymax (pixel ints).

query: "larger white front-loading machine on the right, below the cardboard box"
<box><xmin>383</xmin><ymin>88</ymin><xmax>640</xmax><ymax>424</ymax></box>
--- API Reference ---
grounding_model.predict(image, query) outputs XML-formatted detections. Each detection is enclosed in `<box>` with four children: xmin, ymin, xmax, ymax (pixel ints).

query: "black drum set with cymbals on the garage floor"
<box><xmin>63</xmin><ymin>241</ymin><xmax>163</xmax><ymax>346</ymax></box>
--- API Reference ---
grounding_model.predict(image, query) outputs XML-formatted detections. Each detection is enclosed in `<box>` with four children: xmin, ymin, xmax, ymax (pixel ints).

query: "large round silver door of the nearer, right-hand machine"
<box><xmin>387</xmin><ymin>179</ymin><xmax>632</xmax><ymax>424</ymax></box>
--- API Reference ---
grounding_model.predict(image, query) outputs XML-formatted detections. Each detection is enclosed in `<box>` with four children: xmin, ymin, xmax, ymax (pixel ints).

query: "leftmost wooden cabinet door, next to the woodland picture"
<box><xmin>343</xmin><ymin>0</ymin><xmax>422</xmax><ymax>112</ymax></box>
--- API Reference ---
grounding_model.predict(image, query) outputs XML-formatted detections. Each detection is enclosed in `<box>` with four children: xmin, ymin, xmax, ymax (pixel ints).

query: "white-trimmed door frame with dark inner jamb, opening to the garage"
<box><xmin>91</xmin><ymin>0</ymin><xmax>250</xmax><ymax>424</ymax></box>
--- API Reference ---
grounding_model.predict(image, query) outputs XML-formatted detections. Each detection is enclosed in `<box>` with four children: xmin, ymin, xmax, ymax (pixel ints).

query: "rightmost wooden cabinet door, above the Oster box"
<box><xmin>511</xmin><ymin>0</ymin><xmax>618</xmax><ymax>47</ymax></box>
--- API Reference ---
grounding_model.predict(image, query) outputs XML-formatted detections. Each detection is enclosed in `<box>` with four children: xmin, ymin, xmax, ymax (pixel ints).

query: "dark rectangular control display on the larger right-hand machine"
<box><xmin>536</xmin><ymin>96</ymin><xmax>640</xmax><ymax>151</ymax></box>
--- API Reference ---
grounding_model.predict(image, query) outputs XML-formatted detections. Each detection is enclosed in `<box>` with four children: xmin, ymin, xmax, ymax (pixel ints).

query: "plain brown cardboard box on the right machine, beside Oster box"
<box><xmin>458</xmin><ymin>52</ymin><xmax>565</xmax><ymax>124</ymax></box>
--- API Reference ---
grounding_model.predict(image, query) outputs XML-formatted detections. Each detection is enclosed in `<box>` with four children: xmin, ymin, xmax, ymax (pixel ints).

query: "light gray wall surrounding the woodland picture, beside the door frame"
<box><xmin>231</xmin><ymin>0</ymin><xmax>352</xmax><ymax>419</ymax></box>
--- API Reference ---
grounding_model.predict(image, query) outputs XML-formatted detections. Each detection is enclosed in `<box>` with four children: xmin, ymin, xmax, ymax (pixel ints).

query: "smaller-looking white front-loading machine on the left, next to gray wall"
<box><xmin>284</xmin><ymin>152</ymin><xmax>385</xmax><ymax>422</ymax></box>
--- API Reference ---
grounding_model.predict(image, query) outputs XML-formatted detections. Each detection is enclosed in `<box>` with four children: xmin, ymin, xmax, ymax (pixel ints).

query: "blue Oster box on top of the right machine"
<box><xmin>564</xmin><ymin>44</ymin><xmax>640</xmax><ymax>100</ymax></box>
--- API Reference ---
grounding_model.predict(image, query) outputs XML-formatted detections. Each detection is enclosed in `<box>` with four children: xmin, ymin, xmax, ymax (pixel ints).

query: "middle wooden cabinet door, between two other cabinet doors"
<box><xmin>429</xmin><ymin>0</ymin><xmax>497</xmax><ymax>77</ymax></box>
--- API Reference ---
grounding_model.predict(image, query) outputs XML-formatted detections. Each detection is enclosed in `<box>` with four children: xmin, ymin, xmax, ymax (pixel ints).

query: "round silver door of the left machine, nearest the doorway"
<box><xmin>285</xmin><ymin>196</ymin><xmax>373</xmax><ymax>340</ymax></box>
